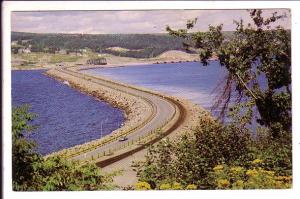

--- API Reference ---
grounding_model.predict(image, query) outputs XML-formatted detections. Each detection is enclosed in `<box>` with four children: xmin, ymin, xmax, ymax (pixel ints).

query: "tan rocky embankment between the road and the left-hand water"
<box><xmin>46</xmin><ymin>70</ymin><xmax>153</xmax><ymax>157</ymax></box>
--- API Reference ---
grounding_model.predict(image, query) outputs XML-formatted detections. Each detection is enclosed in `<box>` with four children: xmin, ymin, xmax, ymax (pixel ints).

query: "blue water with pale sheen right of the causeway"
<box><xmin>82</xmin><ymin>61</ymin><xmax>226</xmax><ymax>110</ymax></box>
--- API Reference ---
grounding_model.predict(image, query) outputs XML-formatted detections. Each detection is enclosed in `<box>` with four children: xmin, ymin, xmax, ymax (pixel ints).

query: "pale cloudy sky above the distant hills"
<box><xmin>11</xmin><ymin>9</ymin><xmax>291</xmax><ymax>34</ymax></box>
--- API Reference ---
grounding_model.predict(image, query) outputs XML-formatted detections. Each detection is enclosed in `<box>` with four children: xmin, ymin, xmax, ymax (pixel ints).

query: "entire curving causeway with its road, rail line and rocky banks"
<box><xmin>46</xmin><ymin>67</ymin><xmax>207</xmax><ymax>167</ymax></box>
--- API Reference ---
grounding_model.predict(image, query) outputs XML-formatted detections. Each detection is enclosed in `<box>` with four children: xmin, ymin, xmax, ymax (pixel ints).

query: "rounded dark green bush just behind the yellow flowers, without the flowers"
<box><xmin>138</xmin><ymin>117</ymin><xmax>250</xmax><ymax>188</ymax></box>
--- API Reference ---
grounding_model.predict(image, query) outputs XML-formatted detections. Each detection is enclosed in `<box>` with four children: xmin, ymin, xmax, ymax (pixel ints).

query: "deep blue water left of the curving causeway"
<box><xmin>12</xmin><ymin>70</ymin><xmax>124</xmax><ymax>155</ymax></box>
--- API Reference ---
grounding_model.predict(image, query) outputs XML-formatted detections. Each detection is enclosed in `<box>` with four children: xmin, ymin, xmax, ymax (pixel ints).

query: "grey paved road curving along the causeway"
<box><xmin>55</xmin><ymin>69</ymin><xmax>175</xmax><ymax>160</ymax></box>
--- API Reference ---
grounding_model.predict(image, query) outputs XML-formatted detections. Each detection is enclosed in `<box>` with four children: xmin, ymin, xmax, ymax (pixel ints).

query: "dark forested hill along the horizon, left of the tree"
<box><xmin>11</xmin><ymin>32</ymin><xmax>236</xmax><ymax>58</ymax></box>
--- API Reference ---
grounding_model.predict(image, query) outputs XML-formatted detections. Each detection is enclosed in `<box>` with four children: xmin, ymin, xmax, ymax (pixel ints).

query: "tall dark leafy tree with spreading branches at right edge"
<box><xmin>167</xmin><ymin>10</ymin><xmax>291</xmax><ymax>137</ymax></box>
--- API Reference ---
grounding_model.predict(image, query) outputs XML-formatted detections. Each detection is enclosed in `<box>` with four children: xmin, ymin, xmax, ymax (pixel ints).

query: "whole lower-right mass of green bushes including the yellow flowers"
<box><xmin>136</xmin><ymin>125</ymin><xmax>292</xmax><ymax>190</ymax></box>
